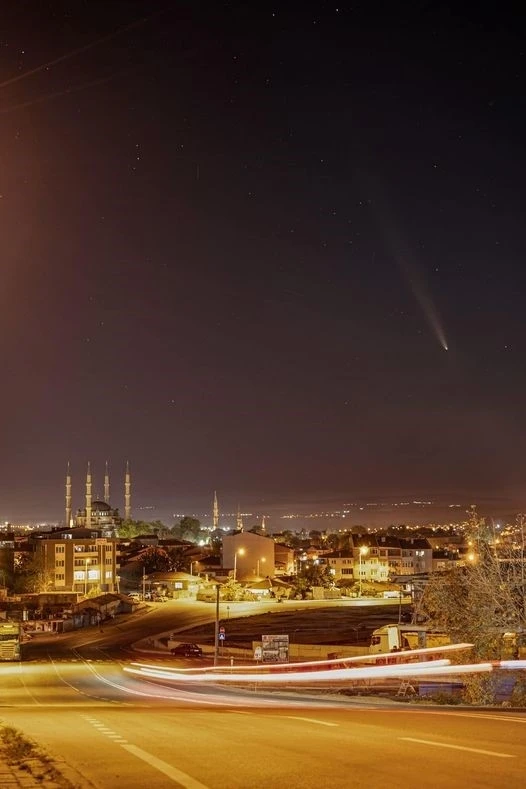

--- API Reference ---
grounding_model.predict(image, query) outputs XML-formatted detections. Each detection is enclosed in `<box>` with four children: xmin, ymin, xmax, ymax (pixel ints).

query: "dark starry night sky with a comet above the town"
<box><xmin>0</xmin><ymin>6</ymin><xmax>526</xmax><ymax>521</ymax></box>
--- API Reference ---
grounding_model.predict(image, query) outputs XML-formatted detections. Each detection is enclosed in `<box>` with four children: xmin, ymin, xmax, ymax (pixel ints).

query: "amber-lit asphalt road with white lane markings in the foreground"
<box><xmin>0</xmin><ymin>606</ymin><xmax>526</xmax><ymax>789</ymax></box>
